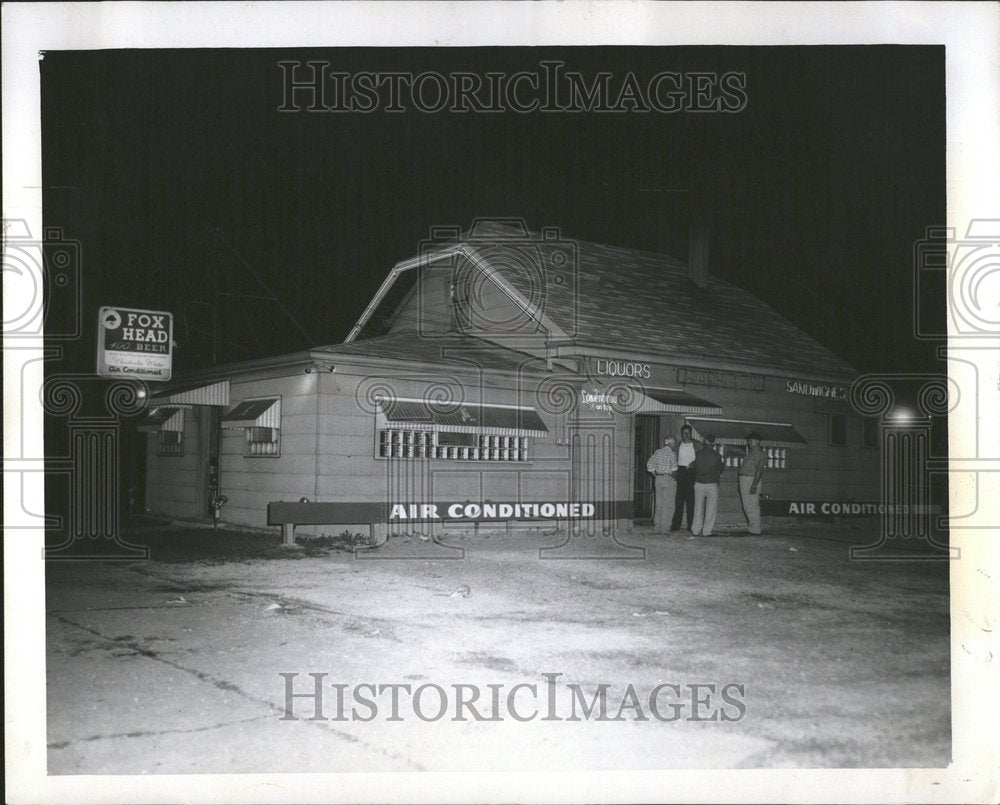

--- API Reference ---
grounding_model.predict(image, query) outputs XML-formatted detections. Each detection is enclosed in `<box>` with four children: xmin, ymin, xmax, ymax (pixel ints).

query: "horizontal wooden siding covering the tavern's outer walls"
<box><xmin>147</xmin><ymin>354</ymin><xmax>880</xmax><ymax>533</ymax></box>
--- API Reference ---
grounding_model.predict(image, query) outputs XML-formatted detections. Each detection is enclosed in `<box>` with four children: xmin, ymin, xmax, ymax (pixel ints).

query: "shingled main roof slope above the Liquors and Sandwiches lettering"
<box><xmin>463</xmin><ymin>223</ymin><xmax>854</xmax><ymax>375</ymax></box>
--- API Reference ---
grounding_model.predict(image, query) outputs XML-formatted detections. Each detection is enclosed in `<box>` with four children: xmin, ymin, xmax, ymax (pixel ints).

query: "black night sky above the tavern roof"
<box><xmin>40</xmin><ymin>46</ymin><xmax>945</xmax><ymax>374</ymax></box>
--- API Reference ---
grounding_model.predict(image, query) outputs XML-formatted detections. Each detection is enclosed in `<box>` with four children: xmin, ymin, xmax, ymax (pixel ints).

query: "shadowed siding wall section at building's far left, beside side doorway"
<box><xmin>146</xmin><ymin>408</ymin><xmax>202</xmax><ymax>518</ymax></box>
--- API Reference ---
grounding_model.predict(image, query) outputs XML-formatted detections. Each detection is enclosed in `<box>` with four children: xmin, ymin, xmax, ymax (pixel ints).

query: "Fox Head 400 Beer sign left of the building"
<box><xmin>97</xmin><ymin>306</ymin><xmax>174</xmax><ymax>380</ymax></box>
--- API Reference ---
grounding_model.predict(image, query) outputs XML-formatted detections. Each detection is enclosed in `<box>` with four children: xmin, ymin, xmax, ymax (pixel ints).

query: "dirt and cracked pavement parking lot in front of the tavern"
<box><xmin>46</xmin><ymin>524</ymin><xmax>950</xmax><ymax>774</ymax></box>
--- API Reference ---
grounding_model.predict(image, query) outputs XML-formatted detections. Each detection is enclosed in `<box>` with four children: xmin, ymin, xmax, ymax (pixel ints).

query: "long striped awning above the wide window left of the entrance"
<box><xmin>376</xmin><ymin>398</ymin><xmax>549</xmax><ymax>436</ymax></box>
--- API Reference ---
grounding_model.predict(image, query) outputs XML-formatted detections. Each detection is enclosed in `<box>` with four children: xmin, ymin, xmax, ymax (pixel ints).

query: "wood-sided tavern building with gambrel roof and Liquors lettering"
<box><xmin>140</xmin><ymin>221</ymin><xmax>879</xmax><ymax>534</ymax></box>
